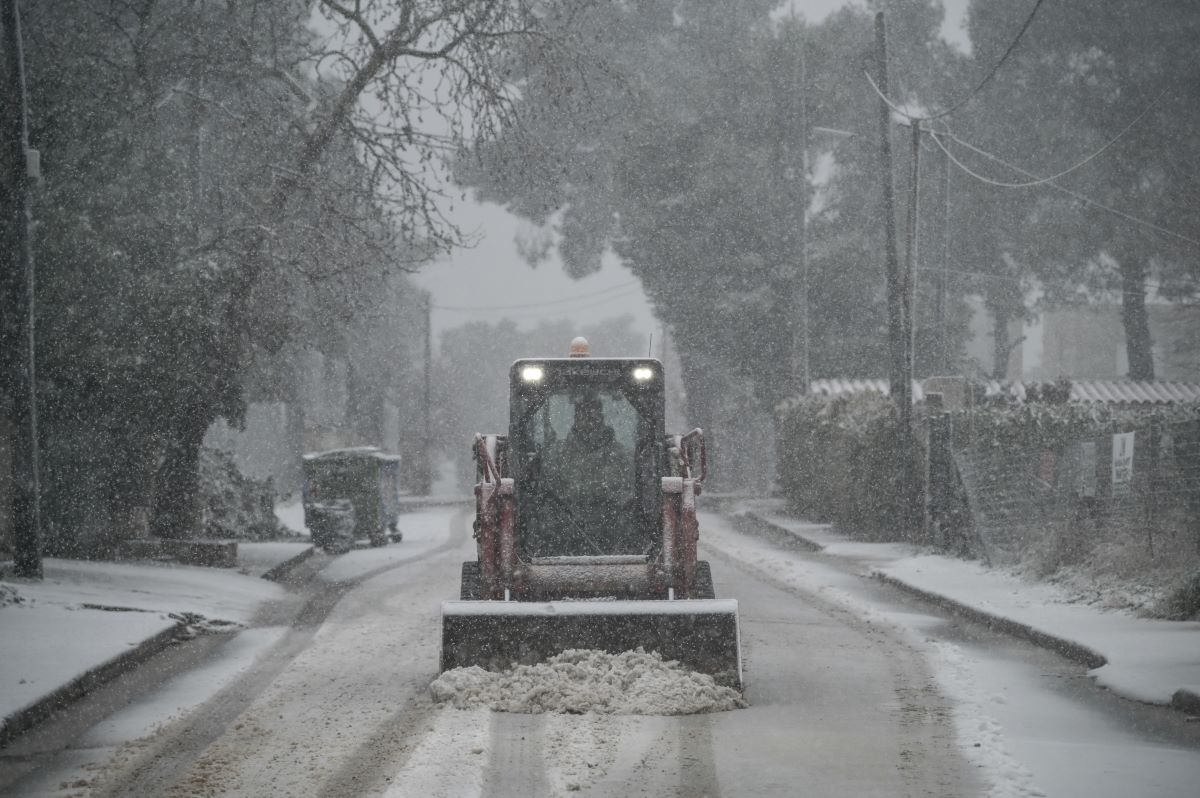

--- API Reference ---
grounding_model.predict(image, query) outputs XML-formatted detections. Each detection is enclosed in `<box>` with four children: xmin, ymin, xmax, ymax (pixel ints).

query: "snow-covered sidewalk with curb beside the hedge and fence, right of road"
<box><xmin>728</xmin><ymin>502</ymin><xmax>1200</xmax><ymax>714</ymax></box>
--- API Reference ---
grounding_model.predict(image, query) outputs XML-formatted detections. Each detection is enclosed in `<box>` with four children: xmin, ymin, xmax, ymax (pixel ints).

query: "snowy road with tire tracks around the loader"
<box><xmin>4</xmin><ymin>509</ymin><xmax>1200</xmax><ymax>798</ymax></box>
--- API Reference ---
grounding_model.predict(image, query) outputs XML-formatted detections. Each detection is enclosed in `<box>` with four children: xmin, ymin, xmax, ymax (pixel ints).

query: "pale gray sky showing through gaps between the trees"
<box><xmin>416</xmin><ymin>0</ymin><xmax>967</xmax><ymax>346</ymax></box>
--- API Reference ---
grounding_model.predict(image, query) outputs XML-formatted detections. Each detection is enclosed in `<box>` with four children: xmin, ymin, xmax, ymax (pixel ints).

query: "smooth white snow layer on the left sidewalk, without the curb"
<box><xmin>0</xmin><ymin>559</ymin><xmax>284</xmax><ymax>718</ymax></box>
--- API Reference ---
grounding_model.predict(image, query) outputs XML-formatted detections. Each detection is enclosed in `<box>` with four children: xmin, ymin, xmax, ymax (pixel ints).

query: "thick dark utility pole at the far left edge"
<box><xmin>0</xmin><ymin>0</ymin><xmax>42</xmax><ymax>578</ymax></box>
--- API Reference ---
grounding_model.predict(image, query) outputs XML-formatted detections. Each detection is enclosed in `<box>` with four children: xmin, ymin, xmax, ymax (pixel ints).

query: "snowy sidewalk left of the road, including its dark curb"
<box><xmin>0</xmin><ymin>541</ymin><xmax>312</xmax><ymax>748</ymax></box>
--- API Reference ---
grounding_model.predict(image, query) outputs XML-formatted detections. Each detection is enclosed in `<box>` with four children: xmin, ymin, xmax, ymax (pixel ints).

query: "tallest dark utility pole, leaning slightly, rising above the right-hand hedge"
<box><xmin>875</xmin><ymin>11</ymin><xmax>905</xmax><ymax>401</ymax></box>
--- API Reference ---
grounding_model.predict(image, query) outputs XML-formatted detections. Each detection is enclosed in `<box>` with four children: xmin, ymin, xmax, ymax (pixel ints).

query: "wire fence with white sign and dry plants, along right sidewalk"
<box><xmin>928</xmin><ymin>415</ymin><xmax>1200</xmax><ymax>568</ymax></box>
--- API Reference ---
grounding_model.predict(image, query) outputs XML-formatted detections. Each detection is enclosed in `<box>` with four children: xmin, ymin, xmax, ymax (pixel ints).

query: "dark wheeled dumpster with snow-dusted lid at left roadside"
<box><xmin>304</xmin><ymin>446</ymin><xmax>400</xmax><ymax>550</ymax></box>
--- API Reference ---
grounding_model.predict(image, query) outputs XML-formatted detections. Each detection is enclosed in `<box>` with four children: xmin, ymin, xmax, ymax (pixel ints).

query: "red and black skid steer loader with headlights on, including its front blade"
<box><xmin>442</xmin><ymin>338</ymin><xmax>742</xmax><ymax>686</ymax></box>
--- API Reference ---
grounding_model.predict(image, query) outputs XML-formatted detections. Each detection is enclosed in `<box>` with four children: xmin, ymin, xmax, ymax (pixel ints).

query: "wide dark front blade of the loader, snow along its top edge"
<box><xmin>442</xmin><ymin>599</ymin><xmax>742</xmax><ymax>688</ymax></box>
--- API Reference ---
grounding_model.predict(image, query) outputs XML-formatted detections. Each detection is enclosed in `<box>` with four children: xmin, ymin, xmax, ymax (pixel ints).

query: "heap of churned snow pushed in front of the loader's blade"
<box><xmin>430</xmin><ymin>649</ymin><xmax>746</xmax><ymax>715</ymax></box>
